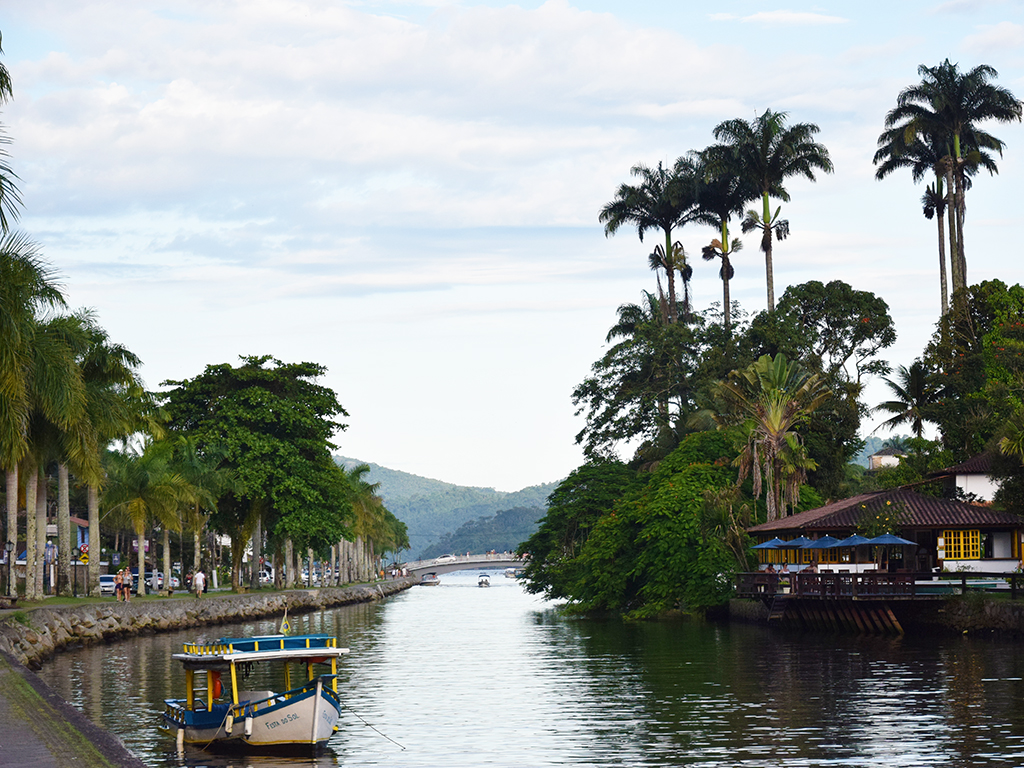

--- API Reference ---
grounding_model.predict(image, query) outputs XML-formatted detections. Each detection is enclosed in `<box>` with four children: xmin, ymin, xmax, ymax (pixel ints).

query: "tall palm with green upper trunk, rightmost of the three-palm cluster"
<box><xmin>713</xmin><ymin>110</ymin><xmax>833</xmax><ymax>312</ymax></box>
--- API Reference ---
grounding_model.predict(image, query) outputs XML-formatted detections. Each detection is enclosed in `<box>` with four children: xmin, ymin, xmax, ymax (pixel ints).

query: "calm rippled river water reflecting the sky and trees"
<box><xmin>41</xmin><ymin>572</ymin><xmax>1024</xmax><ymax>768</ymax></box>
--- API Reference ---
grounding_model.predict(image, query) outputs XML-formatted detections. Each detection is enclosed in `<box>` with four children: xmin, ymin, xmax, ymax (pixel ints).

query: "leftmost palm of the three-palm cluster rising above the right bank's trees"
<box><xmin>598</xmin><ymin>158</ymin><xmax>695</xmax><ymax>323</ymax></box>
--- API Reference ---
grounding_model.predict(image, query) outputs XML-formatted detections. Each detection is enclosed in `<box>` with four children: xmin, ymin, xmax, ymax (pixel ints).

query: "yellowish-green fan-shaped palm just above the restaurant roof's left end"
<box><xmin>717</xmin><ymin>354</ymin><xmax>831</xmax><ymax>521</ymax></box>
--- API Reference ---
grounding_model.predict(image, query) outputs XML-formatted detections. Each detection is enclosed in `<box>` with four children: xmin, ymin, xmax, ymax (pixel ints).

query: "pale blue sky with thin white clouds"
<box><xmin>0</xmin><ymin>0</ymin><xmax>1024</xmax><ymax>490</ymax></box>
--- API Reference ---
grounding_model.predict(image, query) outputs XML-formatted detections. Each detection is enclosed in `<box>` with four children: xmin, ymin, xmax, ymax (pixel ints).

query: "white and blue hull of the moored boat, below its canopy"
<box><xmin>164</xmin><ymin>681</ymin><xmax>341</xmax><ymax>753</ymax></box>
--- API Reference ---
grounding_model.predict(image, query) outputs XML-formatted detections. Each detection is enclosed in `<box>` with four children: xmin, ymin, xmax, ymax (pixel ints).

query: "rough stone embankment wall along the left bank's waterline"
<box><xmin>0</xmin><ymin>579</ymin><xmax>416</xmax><ymax>670</ymax></box>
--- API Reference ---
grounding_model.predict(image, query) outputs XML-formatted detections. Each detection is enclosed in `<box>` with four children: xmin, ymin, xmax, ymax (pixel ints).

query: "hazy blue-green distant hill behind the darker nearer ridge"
<box><xmin>335</xmin><ymin>456</ymin><xmax>558</xmax><ymax>559</ymax></box>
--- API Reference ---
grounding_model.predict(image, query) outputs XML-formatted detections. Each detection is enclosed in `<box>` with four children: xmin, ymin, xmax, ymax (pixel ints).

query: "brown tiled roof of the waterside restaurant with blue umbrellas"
<box><xmin>748</xmin><ymin>489</ymin><xmax>1024</xmax><ymax>534</ymax></box>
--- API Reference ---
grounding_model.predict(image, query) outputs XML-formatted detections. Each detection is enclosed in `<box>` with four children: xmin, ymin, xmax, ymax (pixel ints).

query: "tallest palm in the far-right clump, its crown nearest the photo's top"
<box><xmin>886</xmin><ymin>58</ymin><xmax>1022</xmax><ymax>295</ymax></box>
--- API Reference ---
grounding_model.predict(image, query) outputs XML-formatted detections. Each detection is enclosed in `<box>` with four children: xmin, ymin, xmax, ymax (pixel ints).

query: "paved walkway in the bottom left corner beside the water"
<box><xmin>0</xmin><ymin>652</ymin><xmax>145</xmax><ymax>768</ymax></box>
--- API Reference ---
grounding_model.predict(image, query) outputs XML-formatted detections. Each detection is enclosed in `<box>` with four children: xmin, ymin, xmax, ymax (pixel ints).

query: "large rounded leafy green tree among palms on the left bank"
<box><xmin>163</xmin><ymin>355</ymin><xmax>350</xmax><ymax>587</ymax></box>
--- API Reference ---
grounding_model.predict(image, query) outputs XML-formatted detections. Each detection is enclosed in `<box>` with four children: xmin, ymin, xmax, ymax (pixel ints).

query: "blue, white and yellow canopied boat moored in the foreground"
<box><xmin>164</xmin><ymin>635</ymin><xmax>348</xmax><ymax>754</ymax></box>
